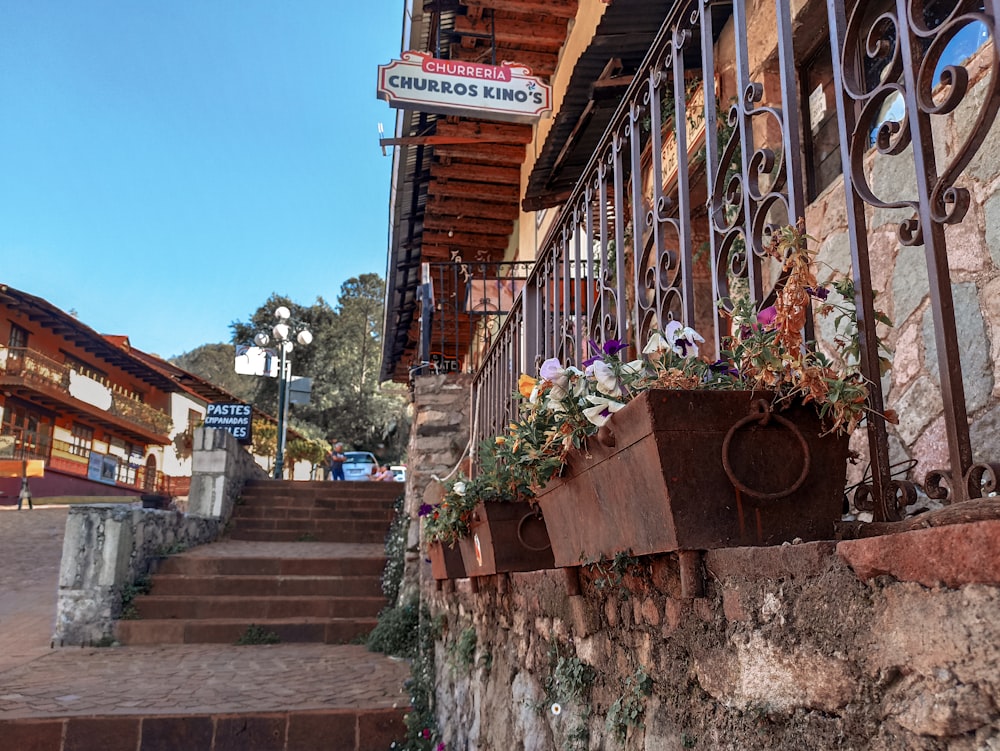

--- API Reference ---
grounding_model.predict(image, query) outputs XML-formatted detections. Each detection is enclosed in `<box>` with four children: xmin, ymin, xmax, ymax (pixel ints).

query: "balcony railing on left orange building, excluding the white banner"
<box><xmin>0</xmin><ymin>347</ymin><xmax>173</xmax><ymax>435</ymax></box>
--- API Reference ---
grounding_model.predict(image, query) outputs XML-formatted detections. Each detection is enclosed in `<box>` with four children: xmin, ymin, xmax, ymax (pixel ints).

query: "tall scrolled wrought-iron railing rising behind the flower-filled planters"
<box><xmin>473</xmin><ymin>0</ymin><xmax>1000</xmax><ymax>521</ymax></box>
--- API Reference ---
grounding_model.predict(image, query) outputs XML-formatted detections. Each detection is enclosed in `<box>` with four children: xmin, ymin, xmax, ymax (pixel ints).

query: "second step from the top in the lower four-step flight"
<box><xmin>151</xmin><ymin>574</ymin><xmax>382</xmax><ymax>605</ymax></box>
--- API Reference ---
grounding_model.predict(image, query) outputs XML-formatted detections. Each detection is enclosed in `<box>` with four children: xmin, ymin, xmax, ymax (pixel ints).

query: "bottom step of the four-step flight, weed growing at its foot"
<box><xmin>115</xmin><ymin>617</ymin><xmax>377</xmax><ymax>646</ymax></box>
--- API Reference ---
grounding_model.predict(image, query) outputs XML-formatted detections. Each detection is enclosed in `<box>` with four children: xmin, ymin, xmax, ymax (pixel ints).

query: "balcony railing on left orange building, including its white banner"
<box><xmin>0</xmin><ymin>347</ymin><xmax>173</xmax><ymax>435</ymax></box>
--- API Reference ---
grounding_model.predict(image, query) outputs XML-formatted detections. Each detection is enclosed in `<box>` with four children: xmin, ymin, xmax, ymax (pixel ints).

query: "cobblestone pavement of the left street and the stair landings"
<box><xmin>0</xmin><ymin>507</ymin><xmax>410</xmax><ymax>719</ymax></box>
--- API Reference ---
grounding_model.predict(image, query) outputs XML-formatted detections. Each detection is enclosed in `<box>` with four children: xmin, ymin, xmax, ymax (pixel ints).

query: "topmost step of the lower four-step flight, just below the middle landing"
<box><xmin>157</xmin><ymin>556</ymin><xmax>385</xmax><ymax>578</ymax></box>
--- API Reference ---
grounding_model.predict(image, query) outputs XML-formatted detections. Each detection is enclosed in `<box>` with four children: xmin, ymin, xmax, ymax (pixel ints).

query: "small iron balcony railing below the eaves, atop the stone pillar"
<box><xmin>419</xmin><ymin>258</ymin><xmax>533</xmax><ymax>373</ymax></box>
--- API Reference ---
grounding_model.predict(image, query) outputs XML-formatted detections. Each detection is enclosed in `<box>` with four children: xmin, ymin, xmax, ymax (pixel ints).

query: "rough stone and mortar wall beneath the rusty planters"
<box><xmin>423</xmin><ymin>521</ymin><xmax>1000</xmax><ymax>751</ymax></box>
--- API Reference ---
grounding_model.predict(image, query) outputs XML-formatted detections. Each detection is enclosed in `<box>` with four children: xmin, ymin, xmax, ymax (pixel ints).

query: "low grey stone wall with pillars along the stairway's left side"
<box><xmin>53</xmin><ymin>428</ymin><xmax>267</xmax><ymax>645</ymax></box>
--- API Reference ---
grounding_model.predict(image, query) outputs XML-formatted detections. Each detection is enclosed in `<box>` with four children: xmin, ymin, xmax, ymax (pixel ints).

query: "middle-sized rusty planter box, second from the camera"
<box><xmin>458</xmin><ymin>501</ymin><xmax>554</xmax><ymax>576</ymax></box>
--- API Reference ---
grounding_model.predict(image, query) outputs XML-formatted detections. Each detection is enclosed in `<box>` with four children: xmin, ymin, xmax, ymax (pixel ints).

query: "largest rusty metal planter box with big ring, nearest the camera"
<box><xmin>537</xmin><ymin>390</ymin><xmax>848</xmax><ymax>566</ymax></box>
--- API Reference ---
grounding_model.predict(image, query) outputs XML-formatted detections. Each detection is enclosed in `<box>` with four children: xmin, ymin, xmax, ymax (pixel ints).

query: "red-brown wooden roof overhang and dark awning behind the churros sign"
<box><xmin>381</xmin><ymin>0</ymin><xmax>673</xmax><ymax>382</ymax></box>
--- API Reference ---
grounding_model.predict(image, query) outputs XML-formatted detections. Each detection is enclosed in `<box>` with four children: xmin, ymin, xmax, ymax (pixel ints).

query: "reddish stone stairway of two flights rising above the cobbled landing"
<box><xmin>117</xmin><ymin>480</ymin><xmax>403</xmax><ymax>645</ymax></box>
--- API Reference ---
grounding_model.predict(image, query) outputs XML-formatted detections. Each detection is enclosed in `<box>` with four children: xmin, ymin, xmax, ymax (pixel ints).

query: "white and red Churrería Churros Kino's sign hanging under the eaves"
<box><xmin>378</xmin><ymin>51</ymin><xmax>552</xmax><ymax>122</ymax></box>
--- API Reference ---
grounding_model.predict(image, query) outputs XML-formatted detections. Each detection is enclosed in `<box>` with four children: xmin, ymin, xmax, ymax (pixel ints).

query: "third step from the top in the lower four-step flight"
<box><xmin>135</xmin><ymin>593</ymin><xmax>385</xmax><ymax>622</ymax></box>
